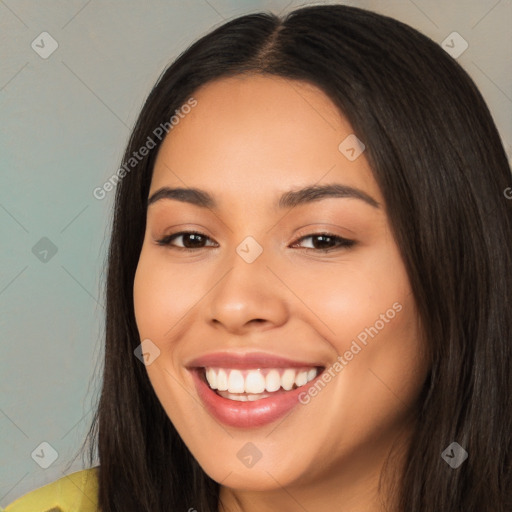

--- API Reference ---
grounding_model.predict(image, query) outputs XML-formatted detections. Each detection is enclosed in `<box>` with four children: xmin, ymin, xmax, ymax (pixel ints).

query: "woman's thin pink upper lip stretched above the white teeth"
<box><xmin>186</xmin><ymin>352</ymin><xmax>324</xmax><ymax>369</ymax></box>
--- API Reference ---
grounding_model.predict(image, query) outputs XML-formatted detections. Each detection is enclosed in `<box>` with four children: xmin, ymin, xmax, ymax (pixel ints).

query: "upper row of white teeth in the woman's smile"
<box><xmin>206</xmin><ymin>368</ymin><xmax>318</xmax><ymax>393</ymax></box>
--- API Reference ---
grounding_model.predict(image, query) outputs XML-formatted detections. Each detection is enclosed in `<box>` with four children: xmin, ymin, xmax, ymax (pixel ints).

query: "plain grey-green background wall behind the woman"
<box><xmin>0</xmin><ymin>0</ymin><xmax>512</xmax><ymax>506</ymax></box>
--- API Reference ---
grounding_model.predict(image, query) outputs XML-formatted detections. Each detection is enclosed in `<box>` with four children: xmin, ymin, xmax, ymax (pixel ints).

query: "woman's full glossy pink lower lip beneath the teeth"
<box><xmin>192</xmin><ymin>369</ymin><xmax>318</xmax><ymax>428</ymax></box>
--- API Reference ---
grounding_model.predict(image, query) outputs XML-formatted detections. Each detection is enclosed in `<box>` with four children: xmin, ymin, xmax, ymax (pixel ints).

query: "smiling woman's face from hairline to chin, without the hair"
<box><xmin>134</xmin><ymin>75</ymin><xmax>427</xmax><ymax>500</ymax></box>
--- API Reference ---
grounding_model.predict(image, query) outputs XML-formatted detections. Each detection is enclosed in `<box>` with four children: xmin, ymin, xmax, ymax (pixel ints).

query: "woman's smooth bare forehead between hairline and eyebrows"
<box><xmin>150</xmin><ymin>75</ymin><xmax>381</xmax><ymax>206</ymax></box>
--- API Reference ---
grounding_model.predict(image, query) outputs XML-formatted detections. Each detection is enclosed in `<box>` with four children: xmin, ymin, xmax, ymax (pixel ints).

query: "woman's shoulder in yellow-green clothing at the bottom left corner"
<box><xmin>0</xmin><ymin>467</ymin><xmax>98</xmax><ymax>512</ymax></box>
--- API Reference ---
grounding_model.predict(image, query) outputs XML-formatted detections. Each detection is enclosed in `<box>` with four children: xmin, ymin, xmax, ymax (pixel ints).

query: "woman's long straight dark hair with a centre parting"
<box><xmin>80</xmin><ymin>5</ymin><xmax>512</xmax><ymax>512</ymax></box>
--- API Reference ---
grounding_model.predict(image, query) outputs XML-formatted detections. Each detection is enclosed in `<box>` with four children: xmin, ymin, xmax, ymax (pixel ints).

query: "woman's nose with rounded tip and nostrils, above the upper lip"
<box><xmin>206</xmin><ymin>245</ymin><xmax>289</xmax><ymax>334</ymax></box>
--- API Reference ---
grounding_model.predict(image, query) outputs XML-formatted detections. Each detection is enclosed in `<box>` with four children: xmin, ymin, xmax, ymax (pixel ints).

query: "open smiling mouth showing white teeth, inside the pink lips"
<box><xmin>198</xmin><ymin>366</ymin><xmax>325</xmax><ymax>402</ymax></box>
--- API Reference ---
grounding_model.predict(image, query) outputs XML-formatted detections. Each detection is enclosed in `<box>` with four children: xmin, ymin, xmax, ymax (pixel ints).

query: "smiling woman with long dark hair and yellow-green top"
<box><xmin>7</xmin><ymin>5</ymin><xmax>512</xmax><ymax>512</ymax></box>
